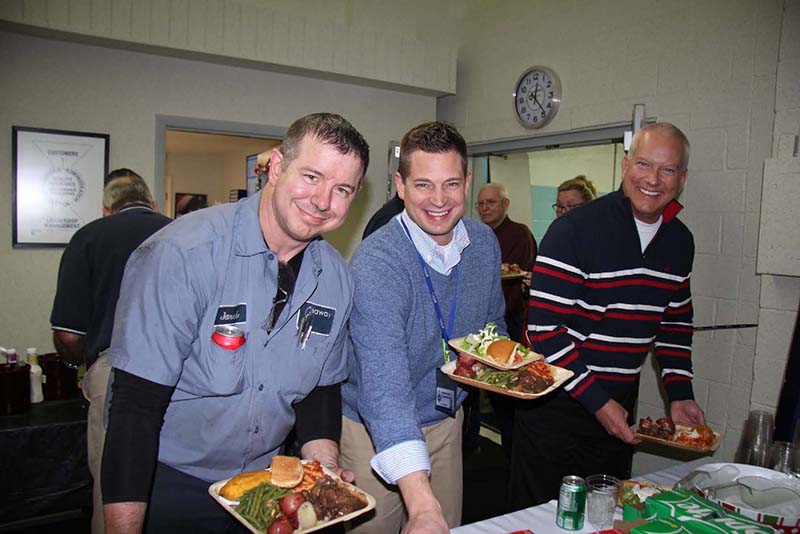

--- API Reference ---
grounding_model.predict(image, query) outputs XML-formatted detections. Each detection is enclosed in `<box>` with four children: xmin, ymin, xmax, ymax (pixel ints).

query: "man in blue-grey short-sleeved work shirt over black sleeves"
<box><xmin>102</xmin><ymin>113</ymin><xmax>369</xmax><ymax>532</ymax></box>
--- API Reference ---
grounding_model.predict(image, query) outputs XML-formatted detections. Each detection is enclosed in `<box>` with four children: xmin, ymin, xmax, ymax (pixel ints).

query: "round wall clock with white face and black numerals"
<box><xmin>514</xmin><ymin>67</ymin><xmax>561</xmax><ymax>128</ymax></box>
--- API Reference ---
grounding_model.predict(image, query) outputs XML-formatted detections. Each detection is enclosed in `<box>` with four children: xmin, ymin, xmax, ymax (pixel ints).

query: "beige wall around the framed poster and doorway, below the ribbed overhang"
<box><xmin>0</xmin><ymin>32</ymin><xmax>436</xmax><ymax>351</ymax></box>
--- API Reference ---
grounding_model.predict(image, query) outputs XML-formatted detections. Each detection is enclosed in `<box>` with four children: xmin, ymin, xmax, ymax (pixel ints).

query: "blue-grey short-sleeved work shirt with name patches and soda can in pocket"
<box><xmin>109</xmin><ymin>193</ymin><xmax>353</xmax><ymax>482</ymax></box>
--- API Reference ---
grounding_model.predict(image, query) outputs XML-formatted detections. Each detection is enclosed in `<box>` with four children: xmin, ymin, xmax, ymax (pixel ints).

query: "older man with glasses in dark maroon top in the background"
<box><xmin>475</xmin><ymin>184</ymin><xmax>536</xmax><ymax>456</ymax></box>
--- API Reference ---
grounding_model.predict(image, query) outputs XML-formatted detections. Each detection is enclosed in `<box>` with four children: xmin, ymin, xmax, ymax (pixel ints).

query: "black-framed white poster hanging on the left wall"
<box><xmin>12</xmin><ymin>126</ymin><xmax>109</xmax><ymax>248</ymax></box>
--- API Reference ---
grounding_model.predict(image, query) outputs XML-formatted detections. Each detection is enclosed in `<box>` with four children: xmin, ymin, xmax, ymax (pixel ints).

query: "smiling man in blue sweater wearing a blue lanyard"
<box><xmin>341</xmin><ymin>122</ymin><xmax>505</xmax><ymax>534</ymax></box>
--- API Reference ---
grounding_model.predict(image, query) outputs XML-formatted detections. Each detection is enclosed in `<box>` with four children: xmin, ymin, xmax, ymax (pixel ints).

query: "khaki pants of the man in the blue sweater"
<box><xmin>340</xmin><ymin>410</ymin><xmax>464</xmax><ymax>534</ymax></box>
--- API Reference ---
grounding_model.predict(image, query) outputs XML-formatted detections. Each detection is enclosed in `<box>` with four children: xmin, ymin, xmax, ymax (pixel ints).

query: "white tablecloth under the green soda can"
<box><xmin>450</xmin><ymin>458</ymin><xmax>709</xmax><ymax>534</ymax></box>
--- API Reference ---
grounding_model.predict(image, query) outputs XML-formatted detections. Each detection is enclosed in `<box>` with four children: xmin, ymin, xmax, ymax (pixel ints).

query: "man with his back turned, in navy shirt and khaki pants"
<box><xmin>50</xmin><ymin>169</ymin><xmax>171</xmax><ymax>534</ymax></box>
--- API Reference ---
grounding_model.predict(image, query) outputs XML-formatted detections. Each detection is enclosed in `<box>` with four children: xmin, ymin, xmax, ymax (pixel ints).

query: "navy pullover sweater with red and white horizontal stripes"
<box><xmin>526</xmin><ymin>190</ymin><xmax>694</xmax><ymax>413</ymax></box>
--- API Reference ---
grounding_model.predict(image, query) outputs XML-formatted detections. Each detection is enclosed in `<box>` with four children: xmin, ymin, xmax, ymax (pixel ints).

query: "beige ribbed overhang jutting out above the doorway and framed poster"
<box><xmin>0</xmin><ymin>0</ymin><xmax>460</xmax><ymax>95</ymax></box>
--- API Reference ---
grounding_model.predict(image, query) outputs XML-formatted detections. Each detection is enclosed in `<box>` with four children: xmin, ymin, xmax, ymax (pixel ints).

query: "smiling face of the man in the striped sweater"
<box><xmin>622</xmin><ymin>131</ymin><xmax>686</xmax><ymax>223</ymax></box>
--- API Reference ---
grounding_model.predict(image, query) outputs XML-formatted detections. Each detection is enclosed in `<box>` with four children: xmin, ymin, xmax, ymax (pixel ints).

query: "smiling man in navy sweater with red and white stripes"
<box><xmin>511</xmin><ymin>123</ymin><xmax>704</xmax><ymax>508</ymax></box>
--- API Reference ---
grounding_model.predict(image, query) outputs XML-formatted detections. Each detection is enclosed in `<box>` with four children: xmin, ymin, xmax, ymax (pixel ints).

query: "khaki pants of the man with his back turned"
<box><xmin>82</xmin><ymin>353</ymin><xmax>111</xmax><ymax>534</ymax></box>
